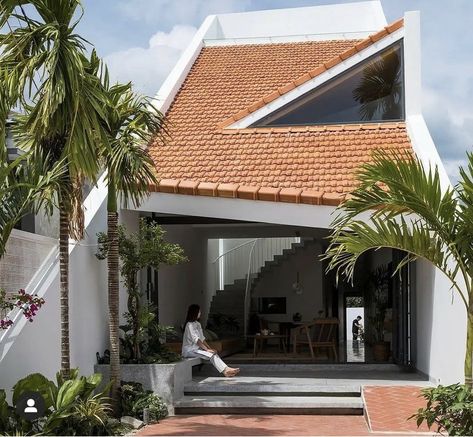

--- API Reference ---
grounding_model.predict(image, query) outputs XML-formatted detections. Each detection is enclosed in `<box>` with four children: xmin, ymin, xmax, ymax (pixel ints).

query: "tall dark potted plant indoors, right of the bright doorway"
<box><xmin>367</xmin><ymin>265</ymin><xmax>391</xmax><ymax>361</ymax></box>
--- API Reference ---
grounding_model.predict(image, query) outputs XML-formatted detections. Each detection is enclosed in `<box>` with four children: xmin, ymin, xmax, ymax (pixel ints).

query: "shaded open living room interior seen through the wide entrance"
<box><xmin>143</xmin><ymin>215</ymin><xmax>414</xmax><ymax>366</ymax></box>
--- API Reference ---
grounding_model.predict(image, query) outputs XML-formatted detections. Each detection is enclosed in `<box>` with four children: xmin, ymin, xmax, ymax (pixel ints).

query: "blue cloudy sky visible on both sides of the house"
<box><xmin>79</xmin><ymin>0</ymin><xmax>473</xmax><ymax>181</ymax></box>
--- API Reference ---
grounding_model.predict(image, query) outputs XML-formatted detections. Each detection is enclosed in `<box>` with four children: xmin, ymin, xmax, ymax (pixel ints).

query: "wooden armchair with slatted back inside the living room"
<box><xmin>291</xmin><ymin>318</ymin><xmax>340</xmax><ymax>361</ymax></box>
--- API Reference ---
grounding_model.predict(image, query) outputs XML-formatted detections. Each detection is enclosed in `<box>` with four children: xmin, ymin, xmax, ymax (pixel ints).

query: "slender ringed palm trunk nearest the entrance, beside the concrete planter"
<box><xmin>107</xmin><ymin>181</ymin><xmax>121</xmax><ymax>417</ymax></box>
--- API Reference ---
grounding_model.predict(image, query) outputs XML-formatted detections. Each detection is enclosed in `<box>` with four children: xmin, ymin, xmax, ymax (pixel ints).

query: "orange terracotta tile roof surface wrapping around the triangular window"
<box><xmin>150</xmin><ymin>17</ymin><xmax>411</xmax><ymax>205</ymax></box>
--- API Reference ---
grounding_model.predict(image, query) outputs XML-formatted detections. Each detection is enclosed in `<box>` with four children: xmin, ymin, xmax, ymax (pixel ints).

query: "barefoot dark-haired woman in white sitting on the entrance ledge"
<box><xmin>182</xmin><ymin>304</ymin><xmax>240</xmax><ymax>377</ymax></box>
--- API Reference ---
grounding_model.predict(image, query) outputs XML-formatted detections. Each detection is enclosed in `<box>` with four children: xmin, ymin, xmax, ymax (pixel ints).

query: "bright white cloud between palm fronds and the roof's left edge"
<box><xmin>105</xmin><ymin>25</ymin><xmax>197</xmax><ymax>96</ymax></box>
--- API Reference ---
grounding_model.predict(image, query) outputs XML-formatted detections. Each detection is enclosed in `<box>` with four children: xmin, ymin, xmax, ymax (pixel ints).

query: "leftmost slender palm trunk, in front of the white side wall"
<box><xmin>59</xmin><ymin>202</ymin><xmax>71</xmax><ymax>379</ymax></box>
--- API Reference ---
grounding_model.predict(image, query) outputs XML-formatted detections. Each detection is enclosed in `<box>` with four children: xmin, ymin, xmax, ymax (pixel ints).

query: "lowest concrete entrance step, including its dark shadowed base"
<box><xmin>174</xmin><ymin>395</ymin><xmax>363</xmax><ymax>415</ymax></box>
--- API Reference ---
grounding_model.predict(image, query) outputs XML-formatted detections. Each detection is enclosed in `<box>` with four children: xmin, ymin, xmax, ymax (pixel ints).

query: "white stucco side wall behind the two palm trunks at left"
<box><xmin>0</xmin><ymin>179</ymin><xmax>108</xmax><ymax>391</ymax></box>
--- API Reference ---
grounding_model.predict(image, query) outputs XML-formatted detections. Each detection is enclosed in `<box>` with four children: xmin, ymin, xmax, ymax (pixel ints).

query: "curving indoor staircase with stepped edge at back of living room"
<box><xmin>208</xmin><ymin>238</ymin><xmax>314</xmax><ymax>337</ymax></box>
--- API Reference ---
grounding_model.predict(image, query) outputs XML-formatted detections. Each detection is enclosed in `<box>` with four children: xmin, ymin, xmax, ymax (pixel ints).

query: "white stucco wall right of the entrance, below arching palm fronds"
<box><xmin>415</xmin><ymin>260</ymin><xmax>466</xmax><ymax>384</ymax></box>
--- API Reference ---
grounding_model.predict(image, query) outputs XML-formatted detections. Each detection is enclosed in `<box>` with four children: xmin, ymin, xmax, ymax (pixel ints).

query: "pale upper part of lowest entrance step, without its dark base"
<box><xmin>174</xmin><ymin>395</ymin><xmax>363</xmax><ymax>409</ymax></box>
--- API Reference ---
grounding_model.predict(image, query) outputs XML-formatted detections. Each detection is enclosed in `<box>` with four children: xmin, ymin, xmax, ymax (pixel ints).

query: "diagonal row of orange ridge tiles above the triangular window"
<box><xmin>218</xmin><ymin>18</ymin><xmax>404</xmax><ymax>129</ymax></box>
